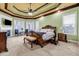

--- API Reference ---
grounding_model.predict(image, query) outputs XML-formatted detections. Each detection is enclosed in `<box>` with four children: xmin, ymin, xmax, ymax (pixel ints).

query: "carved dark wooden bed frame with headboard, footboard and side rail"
<box><xmin>26</xmin><ymin>25</ymin><xmax>57</xmax><ymax>47</ymax></box>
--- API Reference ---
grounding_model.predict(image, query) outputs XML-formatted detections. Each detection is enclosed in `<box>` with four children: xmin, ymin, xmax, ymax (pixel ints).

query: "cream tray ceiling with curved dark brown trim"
<box><xmin>0</xmin><ymin>3</ymin><xmax>75</xmax><ymax>18</ymax></box>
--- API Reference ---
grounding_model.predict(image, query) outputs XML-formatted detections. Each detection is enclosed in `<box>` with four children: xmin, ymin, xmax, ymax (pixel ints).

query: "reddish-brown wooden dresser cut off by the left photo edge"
<box><xmin>0</xmin><ymin>32</ymin><xmax>7</xmax><ymax>52</ymax></box>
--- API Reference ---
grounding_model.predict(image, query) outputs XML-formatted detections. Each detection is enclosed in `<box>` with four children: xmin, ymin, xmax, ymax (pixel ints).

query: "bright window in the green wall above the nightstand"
<box><xmin>63</xmin><ymin>14</ymin><xmax>77</xmax><ymax>35</ymax></box>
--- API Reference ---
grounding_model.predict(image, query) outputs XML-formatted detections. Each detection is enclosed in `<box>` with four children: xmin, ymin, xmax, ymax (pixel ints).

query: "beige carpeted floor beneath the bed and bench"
<box><xmin>0</xmin><ymin>36</ymin><xmax>79</xmax><ymax>56</ymax></box>
